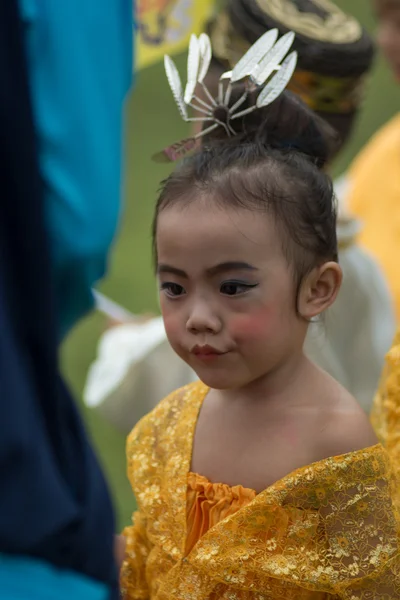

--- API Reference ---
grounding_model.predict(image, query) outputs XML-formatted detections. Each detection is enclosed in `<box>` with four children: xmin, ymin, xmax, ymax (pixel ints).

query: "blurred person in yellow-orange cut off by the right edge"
<box><xmin>346</xmin><ymin>0</ymin><xmax>400</xmax><ymax>322</ymax></box>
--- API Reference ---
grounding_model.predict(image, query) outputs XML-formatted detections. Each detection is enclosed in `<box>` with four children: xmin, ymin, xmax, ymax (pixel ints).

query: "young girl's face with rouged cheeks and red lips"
<box><xmin>156</xmin><ymin>198</ymin><xmax>307</xmax><ymax>389</ymax></box>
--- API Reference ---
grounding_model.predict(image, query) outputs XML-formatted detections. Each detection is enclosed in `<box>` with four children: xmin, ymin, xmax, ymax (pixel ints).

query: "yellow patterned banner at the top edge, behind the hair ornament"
<box><xmin>136</xmin><ymin>0</ymin><xmax>214</xmax><ymax>69</ymax></box>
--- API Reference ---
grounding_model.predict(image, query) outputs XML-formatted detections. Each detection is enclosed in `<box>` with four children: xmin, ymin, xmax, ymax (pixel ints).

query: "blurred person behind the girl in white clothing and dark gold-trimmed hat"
<box><xmin>84</xmin><ymin>0</ymin><xmax>395</xmax><ymax>433</ymax></box>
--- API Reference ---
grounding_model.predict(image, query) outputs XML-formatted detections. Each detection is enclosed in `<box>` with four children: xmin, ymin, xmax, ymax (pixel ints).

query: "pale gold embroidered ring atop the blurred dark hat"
<box><xmin>255</xmin><ymin>0</ymin><xmax>362</xmax><ymax>44</ymax></box>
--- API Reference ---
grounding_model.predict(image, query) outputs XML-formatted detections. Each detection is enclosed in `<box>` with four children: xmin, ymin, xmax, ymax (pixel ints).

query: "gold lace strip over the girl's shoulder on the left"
<box><xmin>120</xmin><ymin>383</ymin><xmax>205</xmax><ymax>600</ymax></box>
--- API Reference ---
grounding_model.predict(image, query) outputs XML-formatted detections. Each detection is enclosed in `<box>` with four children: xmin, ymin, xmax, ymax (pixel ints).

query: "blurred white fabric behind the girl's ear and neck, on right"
<box><xmin>305</xmin><ymin>220</ymin><xmax>396</xmax><ymax>412</ymax></box>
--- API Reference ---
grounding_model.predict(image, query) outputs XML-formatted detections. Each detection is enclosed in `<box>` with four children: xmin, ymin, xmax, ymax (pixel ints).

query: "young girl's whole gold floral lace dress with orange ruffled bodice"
<box><xmin>121</xmin><ymin>382</ymin><xmax>400</xmax><ymax>600</ymax></box>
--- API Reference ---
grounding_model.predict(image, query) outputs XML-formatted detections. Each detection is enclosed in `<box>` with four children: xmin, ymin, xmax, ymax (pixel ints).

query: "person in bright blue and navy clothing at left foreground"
<box><xmin>0</xmin><ymin>0</ymin><xmax>132</xmax><ymax>600</ymax></box>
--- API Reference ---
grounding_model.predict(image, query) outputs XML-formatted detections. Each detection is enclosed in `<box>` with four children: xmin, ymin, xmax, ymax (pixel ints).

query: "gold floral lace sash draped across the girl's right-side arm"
<box><xmin>182</xmin><ymin>445</ymin><xmax>400</xmax><ymax>600</ymax></box>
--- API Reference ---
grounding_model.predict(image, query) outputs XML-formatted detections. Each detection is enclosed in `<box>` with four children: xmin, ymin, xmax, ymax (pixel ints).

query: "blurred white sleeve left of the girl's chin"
<box><xmin>83</xmin><ymin>317</ymin><xmax>196</xmax><ymax>433</ymax></box>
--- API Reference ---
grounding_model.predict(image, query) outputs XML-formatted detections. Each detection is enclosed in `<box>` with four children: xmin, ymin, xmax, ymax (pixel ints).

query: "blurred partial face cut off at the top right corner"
<box><xmin>374</xmin><ymin>0</ymin><xmax>400</xmax><ymax>83</ymax></box>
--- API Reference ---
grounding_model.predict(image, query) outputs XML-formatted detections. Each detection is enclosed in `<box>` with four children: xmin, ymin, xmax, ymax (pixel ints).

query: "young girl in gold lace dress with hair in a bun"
<box><xmin>121</xmin><ymin>34</ymin><xmax>400</xmax><ymax>600</ymax></box>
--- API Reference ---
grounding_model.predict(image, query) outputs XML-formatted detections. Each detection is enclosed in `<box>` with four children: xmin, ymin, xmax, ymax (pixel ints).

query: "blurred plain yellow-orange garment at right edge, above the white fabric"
<box><xmin>348</xmin><ymin>114</ymin><xmax>400</xmax><ymax>320</ymax></box>
